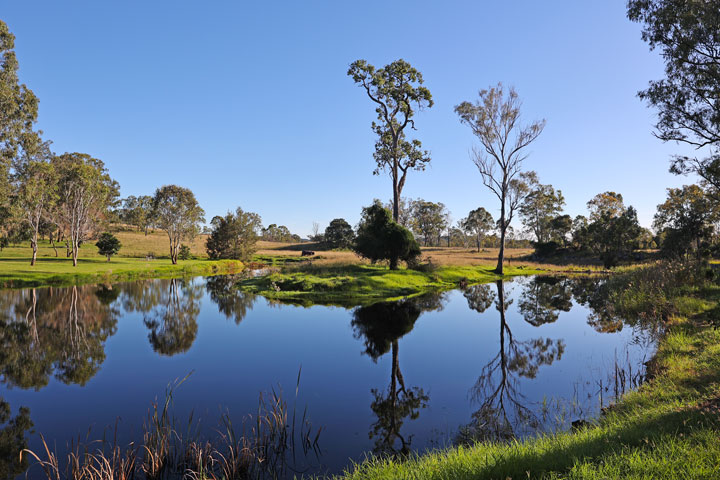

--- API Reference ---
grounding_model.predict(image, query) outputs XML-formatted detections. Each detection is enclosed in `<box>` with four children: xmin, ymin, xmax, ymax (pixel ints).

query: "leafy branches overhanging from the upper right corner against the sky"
<box><xmin>628</xmin><ymin>0</ymin><xmax>720</xmax><ymax>201</ymax></box>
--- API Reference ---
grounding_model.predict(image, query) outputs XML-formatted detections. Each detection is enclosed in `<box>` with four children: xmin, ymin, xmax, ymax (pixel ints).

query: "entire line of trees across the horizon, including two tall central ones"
<box><xmin>0</xmin><ymin>0</ymin><xmax>720</xmax><ymax>273</ymax></box>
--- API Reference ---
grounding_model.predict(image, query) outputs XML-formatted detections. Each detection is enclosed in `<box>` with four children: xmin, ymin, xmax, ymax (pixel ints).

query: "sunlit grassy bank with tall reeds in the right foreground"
<box><xmin>338</xmin><ymin>268</ymin><xmax>720</xmax><ymax>479</ymax></box>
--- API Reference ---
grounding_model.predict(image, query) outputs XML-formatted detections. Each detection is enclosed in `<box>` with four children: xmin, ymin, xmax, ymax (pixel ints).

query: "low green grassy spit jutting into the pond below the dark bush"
<box><xmin>238</xmin><ymin>264</ymin><xmax>539</xmax><ymax>306</ymax></box>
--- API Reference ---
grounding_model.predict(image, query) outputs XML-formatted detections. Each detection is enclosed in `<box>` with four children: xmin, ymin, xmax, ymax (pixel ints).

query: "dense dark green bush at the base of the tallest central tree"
<box><xmin>353</xmin><ymin>202</ymin><xmax>420</xmax><ymax>270</ymax></box>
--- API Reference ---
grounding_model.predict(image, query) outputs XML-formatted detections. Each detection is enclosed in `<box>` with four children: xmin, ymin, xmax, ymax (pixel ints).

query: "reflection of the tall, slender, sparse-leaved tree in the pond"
<box><xmin>456</xmin><ymin>281</ymin><xmax>565</xmax><ymax>443</ymax></box>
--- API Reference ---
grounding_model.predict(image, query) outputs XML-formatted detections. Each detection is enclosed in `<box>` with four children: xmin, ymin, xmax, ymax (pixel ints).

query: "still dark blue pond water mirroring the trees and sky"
<box><xmin>0</xmin><ymin>277</ymin><xmax>654</xmax><ymax>476</ymax></box>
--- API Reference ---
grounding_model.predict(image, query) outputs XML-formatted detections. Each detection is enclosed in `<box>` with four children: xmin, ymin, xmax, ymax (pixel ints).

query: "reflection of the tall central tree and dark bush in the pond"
<box><xmin>352</xmin><ymin>295</ymin><xmax>444</xmax><ymax>455</ymax></box>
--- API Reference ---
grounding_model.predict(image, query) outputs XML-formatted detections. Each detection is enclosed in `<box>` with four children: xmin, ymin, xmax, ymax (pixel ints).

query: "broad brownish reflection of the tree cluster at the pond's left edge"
<box><xmin>0</xmin><ymin>286</ymin><xmax>117</xmax><ymax>389</ymax></box>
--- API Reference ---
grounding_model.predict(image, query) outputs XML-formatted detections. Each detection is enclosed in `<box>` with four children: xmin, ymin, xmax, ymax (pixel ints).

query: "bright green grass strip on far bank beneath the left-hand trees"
<box><xmin>0</xmin><ymin>239</ymin><xmax>243</xmax><ymax>288</ymax></box>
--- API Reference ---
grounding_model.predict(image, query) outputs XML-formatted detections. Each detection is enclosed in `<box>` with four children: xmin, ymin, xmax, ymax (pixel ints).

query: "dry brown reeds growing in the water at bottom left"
<box><xmin>21</xmin><ymin>372</ymin><xmax>322</xmax><ymax>480</ymax></box>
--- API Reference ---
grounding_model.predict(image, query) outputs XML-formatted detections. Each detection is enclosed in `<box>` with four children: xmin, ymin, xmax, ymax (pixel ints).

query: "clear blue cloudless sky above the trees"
<box><xmin>0</xmin><ymin>0</ymin><xmax>694</xmax><ymax>235</ymax></box>
